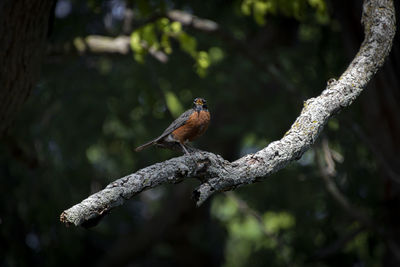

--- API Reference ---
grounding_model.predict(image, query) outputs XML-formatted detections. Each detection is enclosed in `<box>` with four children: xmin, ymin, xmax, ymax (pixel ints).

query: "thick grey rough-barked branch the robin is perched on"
<box><xmin>60</xmin><ymin>0</ymin><xmax>395</xmax><ymax>228</ymax></box>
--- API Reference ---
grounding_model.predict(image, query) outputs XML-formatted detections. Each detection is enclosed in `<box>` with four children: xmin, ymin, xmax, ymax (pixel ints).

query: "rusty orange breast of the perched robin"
<box><xmin>172</xmin><ymin>110</ymin><xmax>210</xmax><ymax>143</ymax></box>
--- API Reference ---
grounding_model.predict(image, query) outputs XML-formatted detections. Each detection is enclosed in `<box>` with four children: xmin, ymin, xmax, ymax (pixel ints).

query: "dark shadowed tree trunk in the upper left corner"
<box><xmin>0</xmin><ymin>0</ymin><xmax>54</xmax><ymax>136</ymax></box>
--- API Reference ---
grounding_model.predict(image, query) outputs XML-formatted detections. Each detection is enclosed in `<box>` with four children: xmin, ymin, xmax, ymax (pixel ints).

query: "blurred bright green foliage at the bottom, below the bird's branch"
<box><xmin>211</xmin><ymin>197</ymin><xmax>295</xmax><ymax>266</ymax></box>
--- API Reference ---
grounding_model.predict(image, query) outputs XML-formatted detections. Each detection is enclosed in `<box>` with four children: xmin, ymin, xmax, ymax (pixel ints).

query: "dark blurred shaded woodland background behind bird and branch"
<box><xmin>0</xmin><ymin>0</ymin><xmax>400</xmax><ymax>266</ymax></box>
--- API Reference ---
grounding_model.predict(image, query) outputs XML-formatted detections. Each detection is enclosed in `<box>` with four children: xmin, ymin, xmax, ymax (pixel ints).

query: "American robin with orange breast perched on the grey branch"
<box><xmin>135</xmin><ymin>98</ymin><xmax>210</xmax><ymax>154</ymax></box>
